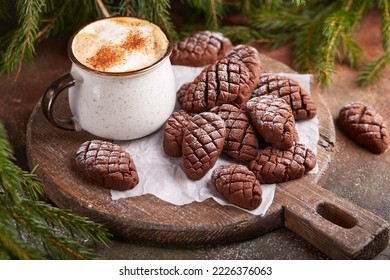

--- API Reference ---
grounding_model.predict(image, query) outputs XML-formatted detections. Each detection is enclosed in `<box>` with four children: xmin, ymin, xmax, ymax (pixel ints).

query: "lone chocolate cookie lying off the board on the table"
<box><xmin>339</xmin><ymin>102</ymin><xmax>389</xmax><ymax>154</ymax></box>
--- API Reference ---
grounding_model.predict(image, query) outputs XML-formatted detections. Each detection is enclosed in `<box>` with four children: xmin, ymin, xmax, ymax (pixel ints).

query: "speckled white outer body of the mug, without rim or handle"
<box><xmin>69</xmin><ymin>59</ymin><xmax>176</xmax><ymax>140</ymax></box>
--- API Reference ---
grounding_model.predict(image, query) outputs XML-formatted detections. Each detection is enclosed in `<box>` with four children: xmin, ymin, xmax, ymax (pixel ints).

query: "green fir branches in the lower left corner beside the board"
<box><xmin>0</xmin><ymin>122</ymin><xmax>110</xmax><ymax>259</ymax></box>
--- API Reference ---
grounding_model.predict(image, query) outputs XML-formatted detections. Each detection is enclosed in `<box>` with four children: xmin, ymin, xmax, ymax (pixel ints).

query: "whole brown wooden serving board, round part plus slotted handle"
<box><xmin>27</xmin><ymin>53</ymin><xmax>388</xmax><ymax>258</ymax></box>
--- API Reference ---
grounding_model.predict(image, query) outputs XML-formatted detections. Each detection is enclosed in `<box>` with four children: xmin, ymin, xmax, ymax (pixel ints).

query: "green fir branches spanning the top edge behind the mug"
<box><xmin>0</xmin><ymin>0</ymin><xmax>390</xmax><ymax>84</ymax></box>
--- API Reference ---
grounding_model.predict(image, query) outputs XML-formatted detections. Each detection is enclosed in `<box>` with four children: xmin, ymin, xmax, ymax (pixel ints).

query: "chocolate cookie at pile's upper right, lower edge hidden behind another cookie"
<box><xmin>252</xmin><ymin>73</ymin><xmax>317</xmax><ymax>120</ymax></box>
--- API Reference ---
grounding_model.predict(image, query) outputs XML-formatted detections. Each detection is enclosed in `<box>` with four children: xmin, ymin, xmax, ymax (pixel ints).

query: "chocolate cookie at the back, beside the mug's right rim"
<box><xmin>170</xmin><ymin>30</ymin><xmax>233</xmax><ymax>67</ymax></box>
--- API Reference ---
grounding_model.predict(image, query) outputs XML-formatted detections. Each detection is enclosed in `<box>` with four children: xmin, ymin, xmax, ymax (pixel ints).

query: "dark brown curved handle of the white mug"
<box><xmin>41</xmin><ymin>73</ymin><xmax>78</xmax><ymax>131</ymax></box>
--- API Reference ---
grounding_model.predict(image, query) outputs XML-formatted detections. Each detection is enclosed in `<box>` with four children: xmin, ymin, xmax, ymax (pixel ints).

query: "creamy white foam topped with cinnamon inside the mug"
<box><xmin>72</xmin><ymin>17</ymin><xmax>169</xmax><ymax>72</ymax></box>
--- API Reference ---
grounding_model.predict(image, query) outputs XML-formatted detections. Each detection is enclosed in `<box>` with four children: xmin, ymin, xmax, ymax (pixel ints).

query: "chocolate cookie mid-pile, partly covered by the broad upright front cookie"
<box><xmin>211</xmin><ymin>104</ymin><xmax>259</xmax><ymax>162</ymax></box>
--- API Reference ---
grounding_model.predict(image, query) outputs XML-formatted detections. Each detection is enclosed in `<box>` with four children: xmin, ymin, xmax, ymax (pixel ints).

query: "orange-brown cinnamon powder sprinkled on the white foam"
<box><xmin>87</xmin><ymin>30</ymin><xmax>150</xmax><ymax>71</ymax></box>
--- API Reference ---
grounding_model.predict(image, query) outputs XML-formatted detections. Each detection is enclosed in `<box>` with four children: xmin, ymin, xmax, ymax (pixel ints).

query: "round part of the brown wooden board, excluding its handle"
<box><xmin>27</xmin><ymin>56</ymin><xmax>335</xmax><ymax>244</ymax></box>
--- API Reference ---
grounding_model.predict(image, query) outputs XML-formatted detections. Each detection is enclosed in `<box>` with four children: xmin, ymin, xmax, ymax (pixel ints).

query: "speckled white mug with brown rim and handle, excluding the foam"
<box><xmin>42</xmin><ymin>16</ymin><xmax>176</xmax><ymax>140</ymax></box>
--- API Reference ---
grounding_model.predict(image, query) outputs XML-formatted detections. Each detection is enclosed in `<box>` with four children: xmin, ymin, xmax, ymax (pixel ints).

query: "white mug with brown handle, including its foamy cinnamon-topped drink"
<box><xmin>42</xmin><ymin>17</ymin><xmax>176</xmax><ymax>140</ymax></box>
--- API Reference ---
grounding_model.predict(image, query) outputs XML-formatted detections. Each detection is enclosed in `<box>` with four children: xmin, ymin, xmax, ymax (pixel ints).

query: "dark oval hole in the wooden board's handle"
<box><xmin>317</xmin><ymin>202</ymin><xmax>357</xmax><ymax>228</ymax></box>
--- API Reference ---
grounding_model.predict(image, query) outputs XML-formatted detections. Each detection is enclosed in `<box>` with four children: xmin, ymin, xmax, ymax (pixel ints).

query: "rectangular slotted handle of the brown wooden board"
<box><xmin>277</xmin><ymin>178</ymin><xmax>389</xmax><ymax>259</ymax></box>
